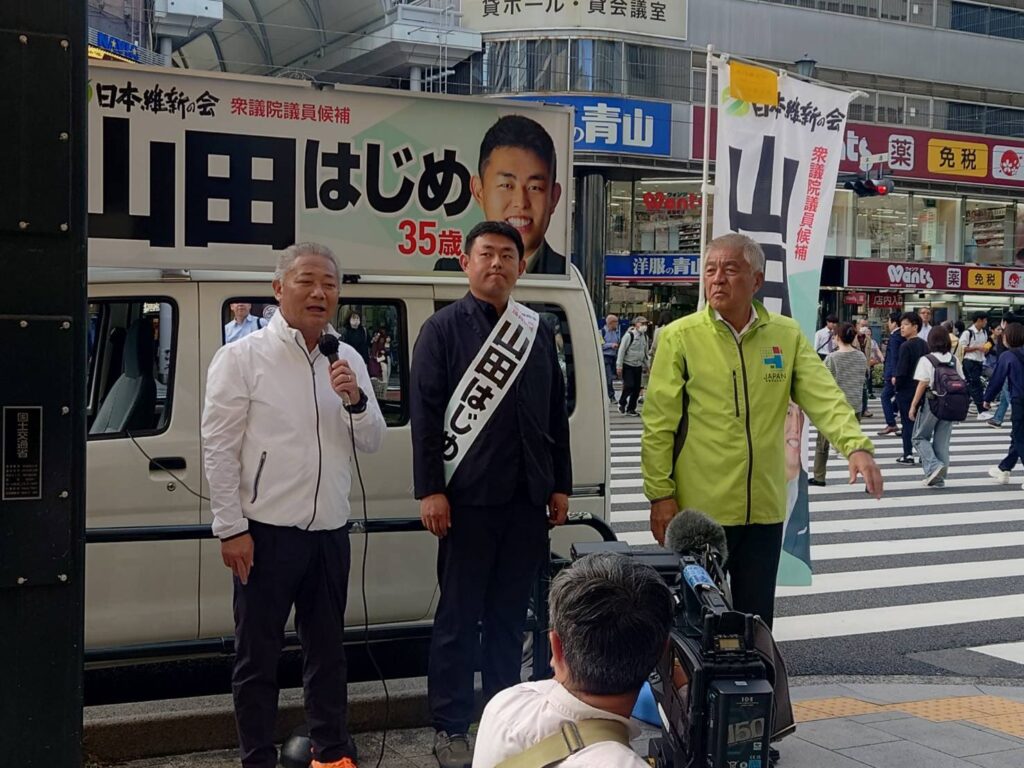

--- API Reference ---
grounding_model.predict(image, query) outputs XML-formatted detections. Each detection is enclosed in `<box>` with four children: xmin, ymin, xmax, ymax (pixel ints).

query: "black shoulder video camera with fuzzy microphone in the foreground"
<box><xmin>572</xmin><ymin>510</ymin><xmax>794</xmax><ymax>768</ymax></box>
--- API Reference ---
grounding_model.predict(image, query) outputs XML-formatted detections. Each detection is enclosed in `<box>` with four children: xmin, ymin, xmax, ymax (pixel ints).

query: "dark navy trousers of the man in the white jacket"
<box><xmin>231</xmin><ymin>520</ymin><xmax>355</xmax><ymax>768</ymax></box>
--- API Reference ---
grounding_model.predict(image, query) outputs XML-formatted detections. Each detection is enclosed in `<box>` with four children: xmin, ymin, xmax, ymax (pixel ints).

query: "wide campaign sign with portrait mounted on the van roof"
<box><xmin>88</xmin><ymin>63</ymin><xmax>572</xmax><ymax>276</ymax></box>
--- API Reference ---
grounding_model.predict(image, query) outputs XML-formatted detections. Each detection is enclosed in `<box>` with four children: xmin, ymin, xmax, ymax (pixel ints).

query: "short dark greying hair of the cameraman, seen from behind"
<box><xmin>550</xmin><ymin>552</ymin><xmax>673</xmax><ymax>695</ymax></box>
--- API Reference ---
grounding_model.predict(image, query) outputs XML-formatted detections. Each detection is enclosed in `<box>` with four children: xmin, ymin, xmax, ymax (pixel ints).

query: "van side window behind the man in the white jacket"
<box><xmin>221</xmin><ymin>296</ymin><xmax>409</xmax><ymax>427</ymax></box>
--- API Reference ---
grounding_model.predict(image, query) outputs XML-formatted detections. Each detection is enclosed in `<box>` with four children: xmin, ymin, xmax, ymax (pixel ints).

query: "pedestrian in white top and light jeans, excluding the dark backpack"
<box><xmin>909</xmin><ymin>326</ymin><xmax>964</xmax><ymax>488</ymax></box>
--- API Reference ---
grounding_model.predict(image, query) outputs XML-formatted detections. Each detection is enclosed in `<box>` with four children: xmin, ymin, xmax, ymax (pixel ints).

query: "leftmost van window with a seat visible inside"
<box><xmin>87</xmin><ymin>297</ymin><xmax>177</xmax><ymax>438</ymax></box>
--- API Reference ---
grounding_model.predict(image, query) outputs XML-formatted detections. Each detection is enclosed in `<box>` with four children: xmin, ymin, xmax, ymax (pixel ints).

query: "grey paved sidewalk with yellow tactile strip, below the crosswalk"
<box><xmin>88</xmin><ymin>678</ymin><xmax>1024</xmax><ymax>768</ymax></box>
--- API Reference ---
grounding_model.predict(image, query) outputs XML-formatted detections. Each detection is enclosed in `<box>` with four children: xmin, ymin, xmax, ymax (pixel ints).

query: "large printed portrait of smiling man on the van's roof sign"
<box><xmin>434</xmin><ymin>115</ymin><xmax>565</xmax><ymax>274</ymax></box>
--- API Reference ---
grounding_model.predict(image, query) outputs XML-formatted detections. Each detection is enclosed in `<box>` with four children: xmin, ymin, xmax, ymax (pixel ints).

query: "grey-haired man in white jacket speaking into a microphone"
<box><xmin>203</xmin><ymin>243</ymin><xmax>385</xmax><ymax>768</ymax></box>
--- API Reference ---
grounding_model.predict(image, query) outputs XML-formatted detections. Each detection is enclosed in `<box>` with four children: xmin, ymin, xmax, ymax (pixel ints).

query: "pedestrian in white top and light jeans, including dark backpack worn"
<box><xmin>909</xmin><ymin>326</ymin><xmax>971</xmax><ymax>487</ymax></box>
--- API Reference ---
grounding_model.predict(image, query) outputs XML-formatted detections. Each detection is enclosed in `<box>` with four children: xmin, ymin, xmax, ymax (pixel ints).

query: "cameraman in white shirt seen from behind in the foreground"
<box><xmin>473</xmin><ymin>553</ymin><xmax>673</xmax><ymax>768</ymax></box>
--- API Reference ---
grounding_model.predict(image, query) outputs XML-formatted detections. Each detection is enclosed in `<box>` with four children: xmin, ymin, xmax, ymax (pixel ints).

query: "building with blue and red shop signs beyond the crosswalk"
<box><xmin>142</xmin><ymin>0</ymin><xmax>1024</xmax><ymax>319</ymax></box>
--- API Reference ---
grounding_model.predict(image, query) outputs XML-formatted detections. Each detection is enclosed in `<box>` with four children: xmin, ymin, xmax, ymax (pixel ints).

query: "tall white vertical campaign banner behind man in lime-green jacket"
<box><xmin>713</xmin><ymin>62</ymin><xmax>850</xmax><ymax>586</ymax></box>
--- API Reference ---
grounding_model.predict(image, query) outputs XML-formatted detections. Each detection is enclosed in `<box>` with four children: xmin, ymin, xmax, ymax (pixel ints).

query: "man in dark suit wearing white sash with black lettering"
<box><xmin>411</xmin><ymin>221</ymin><xmax>572</xmax><ymax>768</ymax></box>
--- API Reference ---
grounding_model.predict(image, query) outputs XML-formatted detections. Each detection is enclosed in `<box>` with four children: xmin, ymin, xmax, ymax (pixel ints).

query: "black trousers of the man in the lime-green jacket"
<box><xmin>723</xmin><ymin>522</ymin><xmax>782</xmax><ymax>629</ymax></box>
